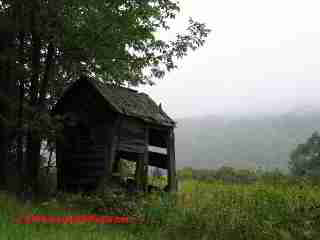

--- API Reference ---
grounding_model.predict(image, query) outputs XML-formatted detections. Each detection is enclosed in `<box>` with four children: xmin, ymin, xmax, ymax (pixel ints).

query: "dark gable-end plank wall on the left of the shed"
<box><xmin>57</xmin><ymin>84</ymin><xmax>117</xmax><ymax>191</ymax></box>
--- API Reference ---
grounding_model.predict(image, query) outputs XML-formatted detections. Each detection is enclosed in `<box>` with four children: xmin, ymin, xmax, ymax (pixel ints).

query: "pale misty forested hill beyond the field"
<box><xmin>176</xmin><ymin>109</ymin><xmax>320</xmax><ymax>170</ymax></box>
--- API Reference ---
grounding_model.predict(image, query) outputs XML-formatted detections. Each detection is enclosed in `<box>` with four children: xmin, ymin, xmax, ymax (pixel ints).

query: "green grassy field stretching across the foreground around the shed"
<box><xmin>0</xmin><ymin>180</ymin><xmax>320</xmax><ymax>240</ymax></box>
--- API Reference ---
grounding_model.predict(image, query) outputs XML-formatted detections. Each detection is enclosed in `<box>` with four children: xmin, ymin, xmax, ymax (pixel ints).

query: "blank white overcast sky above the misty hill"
<box><xmin>140</xmin><ymin>0</ymin><xmax>320</xmax><ymax>118</ymax></box>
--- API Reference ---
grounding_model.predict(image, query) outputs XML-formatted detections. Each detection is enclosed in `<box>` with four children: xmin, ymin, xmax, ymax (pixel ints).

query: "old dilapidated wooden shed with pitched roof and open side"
<box><xmin>53</xmin><ymin>76</ymin><xmax>177</xmax><ymax>191</ymax></box>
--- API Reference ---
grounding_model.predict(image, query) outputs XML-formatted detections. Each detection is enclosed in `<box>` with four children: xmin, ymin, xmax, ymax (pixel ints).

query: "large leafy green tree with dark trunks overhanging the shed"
<box><xmin>0</xmin><ymin>0</ymin><xmax>210</xmax><ymax>194</ymax></box>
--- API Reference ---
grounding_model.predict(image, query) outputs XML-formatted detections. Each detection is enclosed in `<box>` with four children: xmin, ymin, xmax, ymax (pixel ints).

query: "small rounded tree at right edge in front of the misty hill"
<box><xmin>289</xmin><ymin>132</ymin><xmax>320</xmax><ymax>176</ymax></box>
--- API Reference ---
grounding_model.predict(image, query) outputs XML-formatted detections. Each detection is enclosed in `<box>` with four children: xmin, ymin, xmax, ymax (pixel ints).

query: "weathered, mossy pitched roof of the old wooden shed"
<box><xmin>57</xmin><ymin>77</ymin><xmax>175</xmax><ymax>126</ymax></box>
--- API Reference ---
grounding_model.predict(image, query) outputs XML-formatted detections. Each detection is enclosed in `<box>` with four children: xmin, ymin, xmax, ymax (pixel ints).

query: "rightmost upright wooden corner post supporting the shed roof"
<box><xmin>167</xmin><ymin>128</ymin><xmax>177</xmax><ymax>192</ymax></box>
